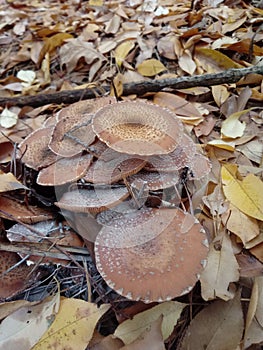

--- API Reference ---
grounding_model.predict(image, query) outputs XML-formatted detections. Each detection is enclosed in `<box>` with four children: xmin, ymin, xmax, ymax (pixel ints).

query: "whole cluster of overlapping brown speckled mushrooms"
<box><xmin>20</xmin><ymin>97</ymin><xmax>210</xmax><ymax>302</ymax></box>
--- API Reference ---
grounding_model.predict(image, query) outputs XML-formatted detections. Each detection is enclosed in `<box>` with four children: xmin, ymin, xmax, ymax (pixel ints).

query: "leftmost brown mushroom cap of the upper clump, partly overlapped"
<box><xmin>18</xmin><ymin>127</ymin><xmax>58</xmax><ymax>170</ymax></box>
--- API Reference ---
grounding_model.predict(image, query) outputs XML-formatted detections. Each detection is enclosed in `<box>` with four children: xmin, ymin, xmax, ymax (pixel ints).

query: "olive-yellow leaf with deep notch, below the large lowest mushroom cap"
<box><xmin>114</xmin><ymin>301</ymin><xmax>186</xmax><ymax>345</ymax></box>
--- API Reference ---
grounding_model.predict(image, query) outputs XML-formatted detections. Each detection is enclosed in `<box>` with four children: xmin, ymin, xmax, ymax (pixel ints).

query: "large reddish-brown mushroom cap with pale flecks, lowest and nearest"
<box><xmin>95</xmin><ymin>208</ymin><xmax>208</xmax><ymax>303</ymax></box>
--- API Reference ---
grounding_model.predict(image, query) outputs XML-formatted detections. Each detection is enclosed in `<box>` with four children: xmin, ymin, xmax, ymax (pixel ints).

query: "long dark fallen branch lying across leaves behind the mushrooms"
<box><xmin>0</xmin><ymin>66</ymin><xmax>263</xmax><ymax>107</ymax></box>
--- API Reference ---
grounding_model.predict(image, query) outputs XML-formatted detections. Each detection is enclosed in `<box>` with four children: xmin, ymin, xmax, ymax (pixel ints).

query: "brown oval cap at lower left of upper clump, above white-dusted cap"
<box><xmin>37</xmin><ymin>154</ymin><xmax>92</xmax><ymax>186</ymax></box>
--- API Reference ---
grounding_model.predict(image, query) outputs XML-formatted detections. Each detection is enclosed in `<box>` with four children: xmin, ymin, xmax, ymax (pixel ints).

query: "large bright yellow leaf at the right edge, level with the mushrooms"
<box><xmin>221</xmin><ymin>164</ymin><xmax>263</xmax><ymax>220</ymax></box>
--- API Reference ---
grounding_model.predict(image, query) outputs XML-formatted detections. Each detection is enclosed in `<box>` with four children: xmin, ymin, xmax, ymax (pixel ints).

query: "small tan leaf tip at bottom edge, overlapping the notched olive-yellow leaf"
<box><xmin>121</xmin><ymin>315</ymin><xmax>165</xmax><ymax>350</ymax></box>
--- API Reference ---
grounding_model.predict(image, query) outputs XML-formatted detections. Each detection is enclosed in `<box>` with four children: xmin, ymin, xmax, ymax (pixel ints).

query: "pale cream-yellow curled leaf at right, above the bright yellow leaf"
<box><xmin>221</xmin><ymin>109</ymin><xmax>250</xmax><ymax>139</ymax></box>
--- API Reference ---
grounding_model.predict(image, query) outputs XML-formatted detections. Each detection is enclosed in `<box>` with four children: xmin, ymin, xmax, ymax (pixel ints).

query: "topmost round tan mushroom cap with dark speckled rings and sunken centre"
<box><xmin>92</xmin><ymin>101</ymin><xmax>183</xmax><ymax>156</ymax></box>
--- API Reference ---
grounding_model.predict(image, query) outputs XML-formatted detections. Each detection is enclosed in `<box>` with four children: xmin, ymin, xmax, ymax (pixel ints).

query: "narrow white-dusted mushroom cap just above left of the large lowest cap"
<box><xmin>55</xmin><ymin>187</ymin><xmax>129</xmax><ymax>213</ymax></box>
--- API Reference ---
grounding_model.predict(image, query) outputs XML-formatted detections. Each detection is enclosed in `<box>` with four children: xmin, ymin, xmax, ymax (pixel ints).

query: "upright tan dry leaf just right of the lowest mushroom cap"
<box><xmin>200</xmin><ymin>233</ymin><xmax>239</xmax><ymax>300</ymax></box>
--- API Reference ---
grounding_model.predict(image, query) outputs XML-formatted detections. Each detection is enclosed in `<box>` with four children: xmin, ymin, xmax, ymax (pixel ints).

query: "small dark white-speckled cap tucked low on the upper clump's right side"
<box><xmin>129</xmin><ymin>170</ymin><xmax>180</xmax><ymax>191</ymax></box>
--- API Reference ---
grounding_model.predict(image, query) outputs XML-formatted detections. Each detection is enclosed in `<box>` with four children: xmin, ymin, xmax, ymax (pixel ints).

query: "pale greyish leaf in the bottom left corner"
<box><xmin>0</xmin><ymin>293</ymin><xmax>60</xmax><ymax>350</ymax></box>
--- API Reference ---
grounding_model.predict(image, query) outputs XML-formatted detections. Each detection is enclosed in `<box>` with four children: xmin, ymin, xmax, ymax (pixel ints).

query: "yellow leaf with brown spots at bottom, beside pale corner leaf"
<box><xmin>33</xmin><ymin>298</ymin><xmax>110</xmax><ymax>350</ymax></box>
